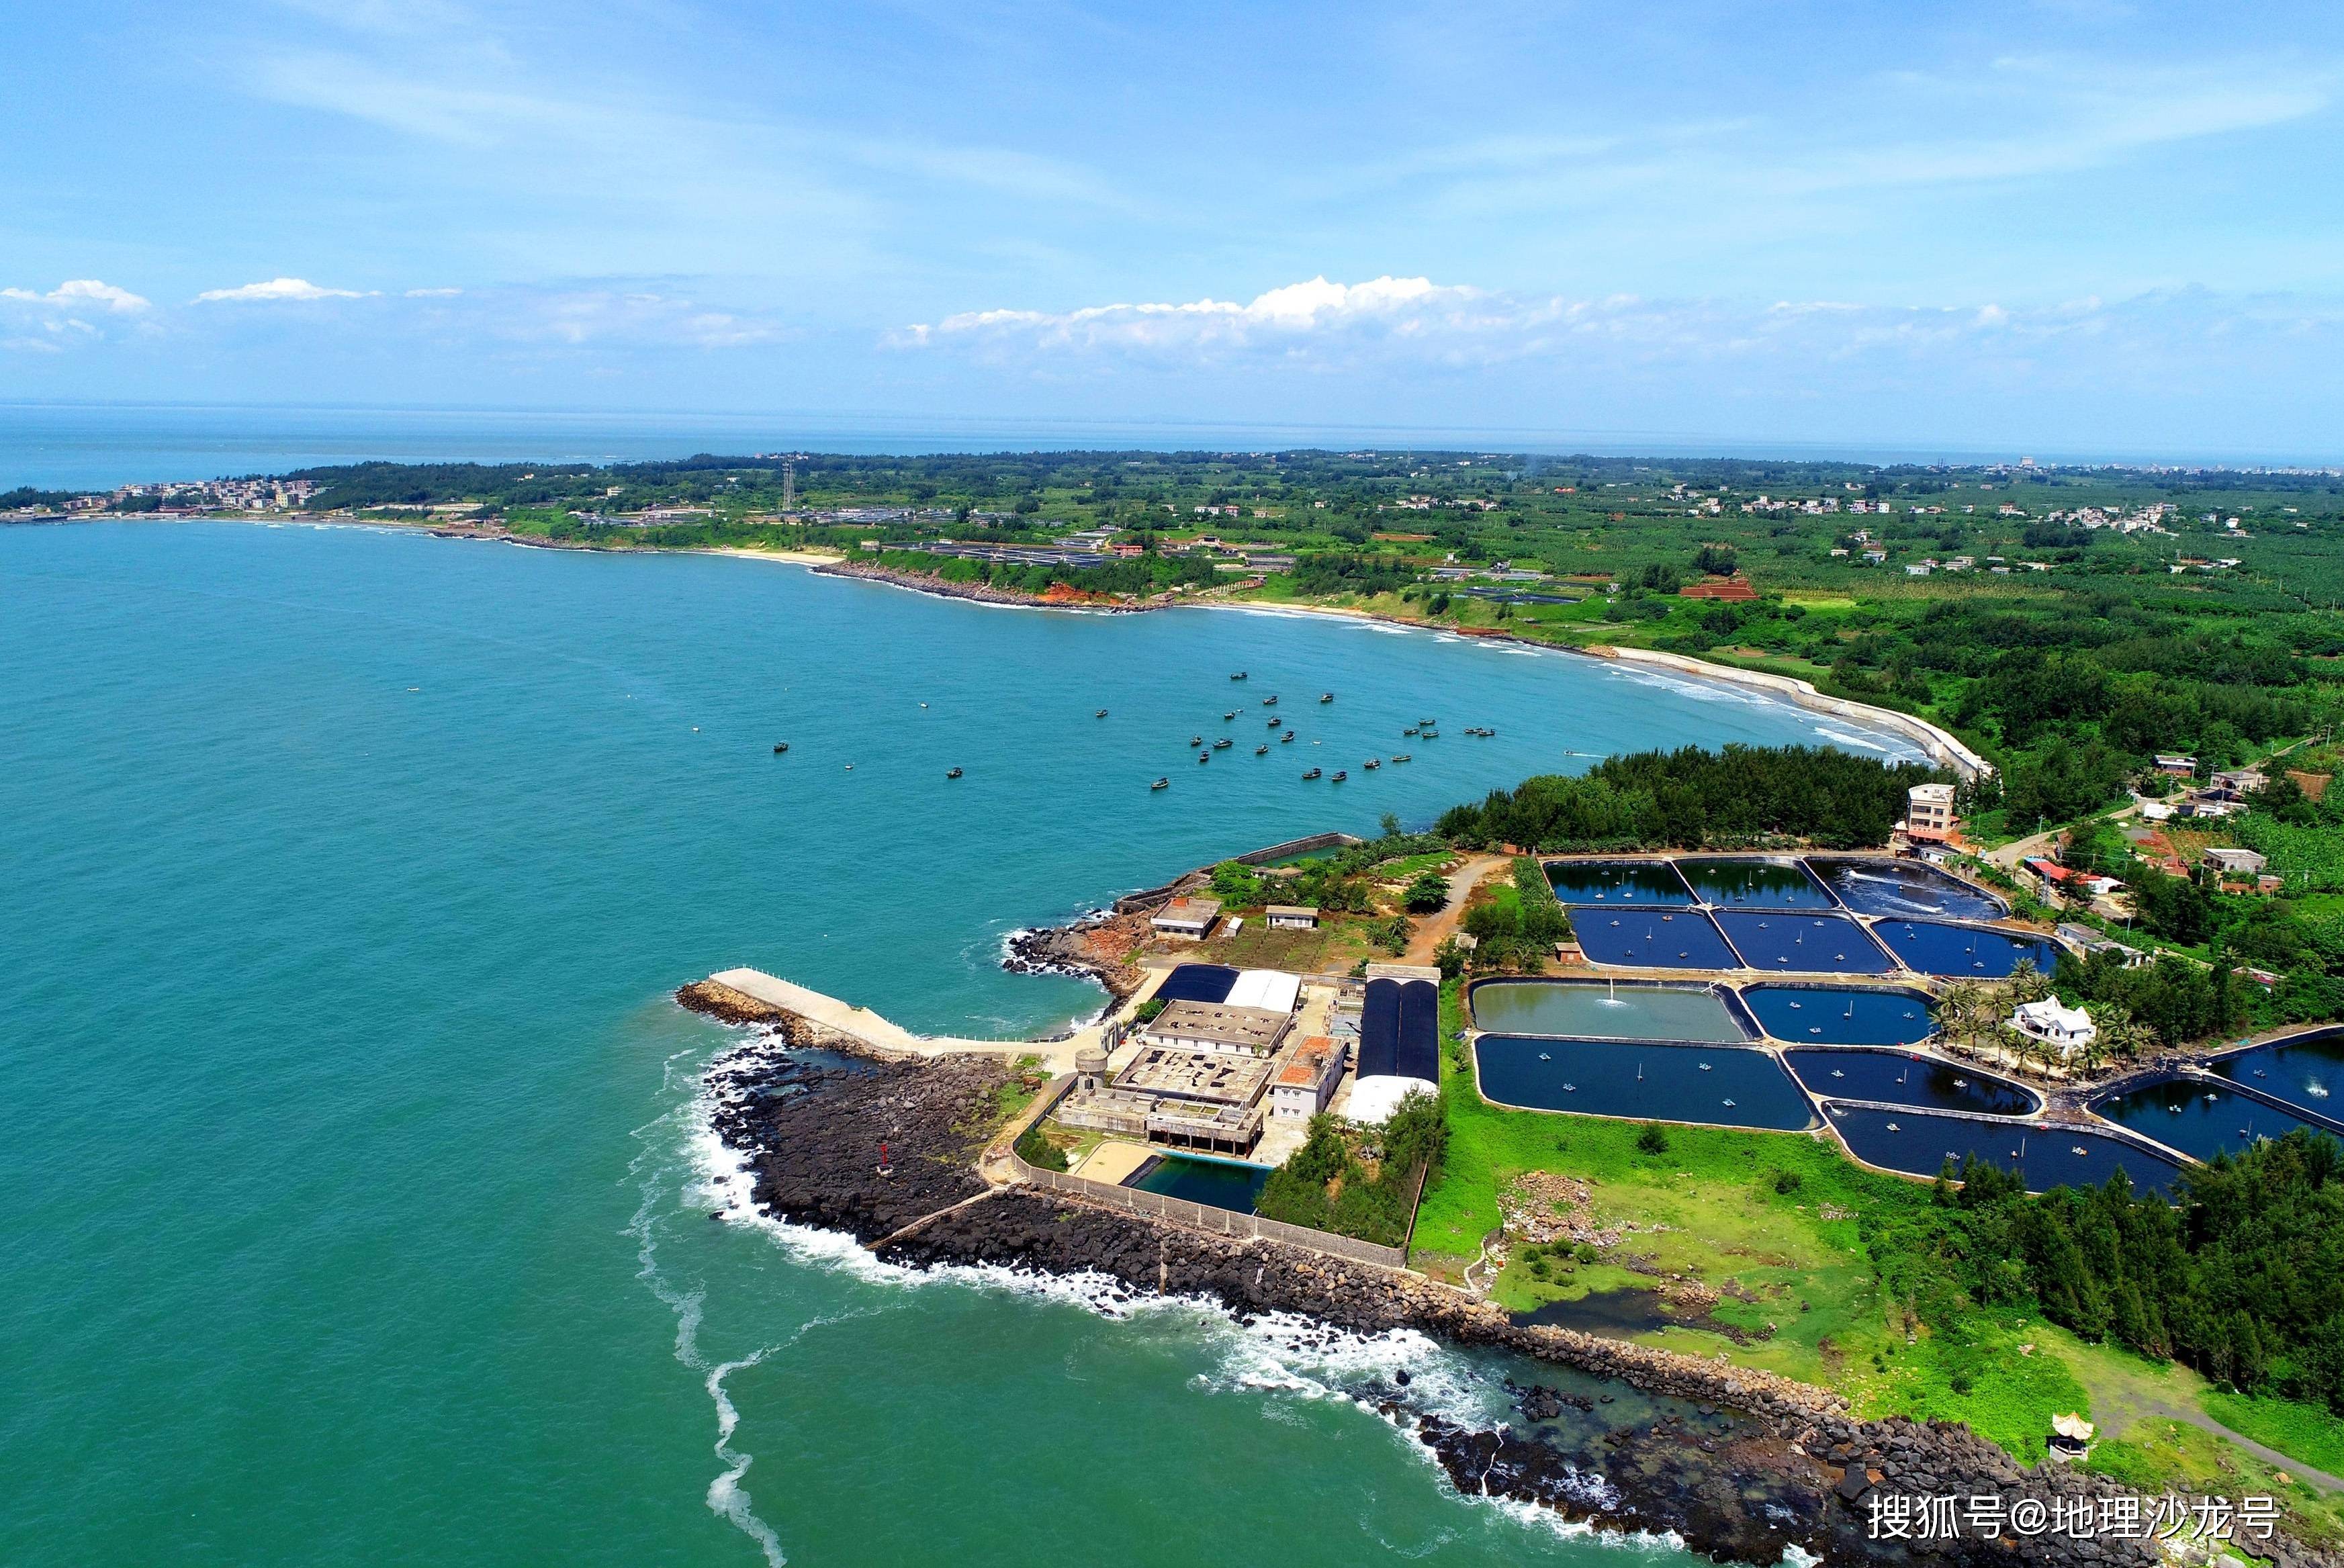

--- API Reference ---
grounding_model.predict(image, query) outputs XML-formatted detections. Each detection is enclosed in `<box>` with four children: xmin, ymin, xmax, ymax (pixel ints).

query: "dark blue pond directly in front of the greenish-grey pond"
<box><xmin>1474</xmin><ymin>1033</ymin><xmax>1814</xmax><ymax>1132</ymax></box>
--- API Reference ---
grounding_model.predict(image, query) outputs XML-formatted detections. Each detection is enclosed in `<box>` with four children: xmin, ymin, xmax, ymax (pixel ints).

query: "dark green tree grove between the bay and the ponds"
<box><xmin>1435</xmin><ymin>745</ymin><xmax>1948</xmax><ymax>851</ymax></box>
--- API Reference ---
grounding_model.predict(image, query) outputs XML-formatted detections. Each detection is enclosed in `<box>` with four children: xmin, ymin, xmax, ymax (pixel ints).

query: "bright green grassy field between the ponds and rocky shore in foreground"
<box><xmin>1411</xmin><ymin>984</ymin><xmax>2344</xmax><ymax>1491</ymax></box>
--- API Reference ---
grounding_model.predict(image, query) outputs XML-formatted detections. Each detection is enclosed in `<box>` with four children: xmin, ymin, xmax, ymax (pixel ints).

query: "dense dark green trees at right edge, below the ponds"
<box><xmin>1868</xmin><ymin>1129</ymin><xmax>2344</xmax><ymax>1414</ymax></box>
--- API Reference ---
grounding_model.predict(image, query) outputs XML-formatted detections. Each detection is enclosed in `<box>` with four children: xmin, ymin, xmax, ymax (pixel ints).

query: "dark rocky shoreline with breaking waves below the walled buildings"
<box><xmin>687</xmin><ymin>1031</ymin><xmax>2337</xmax><ymax>1568</ymax></box>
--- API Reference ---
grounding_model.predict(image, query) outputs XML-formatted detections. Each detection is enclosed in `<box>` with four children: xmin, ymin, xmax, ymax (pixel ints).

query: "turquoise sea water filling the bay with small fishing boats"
<box><xmin>0</xmin><ymin>525</ymin><xmax>1903</xmax><ymax>1566</ymax></box>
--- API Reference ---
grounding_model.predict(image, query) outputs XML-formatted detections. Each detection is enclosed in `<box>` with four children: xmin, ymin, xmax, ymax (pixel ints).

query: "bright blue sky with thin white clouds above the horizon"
<box><xmin>0</xmin><ymin>0</ymin><xmax>2344</xmax><ymax>459</ymax></box>
